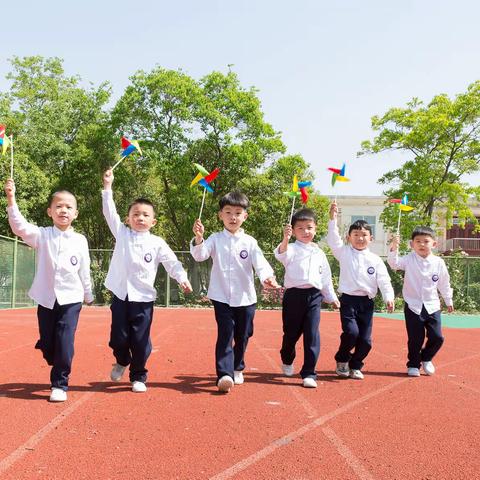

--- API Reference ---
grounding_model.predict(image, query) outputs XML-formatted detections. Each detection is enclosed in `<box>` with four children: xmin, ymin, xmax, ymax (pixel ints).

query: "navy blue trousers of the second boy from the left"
<box><xmin>108</xmin><ymin>295</ymin><xmax>153</xmax><ymax>383</ymax></box>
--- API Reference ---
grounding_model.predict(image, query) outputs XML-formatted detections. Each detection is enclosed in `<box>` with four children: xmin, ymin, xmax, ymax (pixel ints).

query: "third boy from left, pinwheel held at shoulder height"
<box><xmin>190</xmin><ymin>192</ymin><xmax>278</xmax><ymax>393</ymax></box>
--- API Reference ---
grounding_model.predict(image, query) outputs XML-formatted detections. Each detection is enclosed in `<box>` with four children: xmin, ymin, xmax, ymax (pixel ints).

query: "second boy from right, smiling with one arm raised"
<box><xmin>327</xmin><ymin>202</ymin><xmax>394</xmax><ymax>380</ymax></box>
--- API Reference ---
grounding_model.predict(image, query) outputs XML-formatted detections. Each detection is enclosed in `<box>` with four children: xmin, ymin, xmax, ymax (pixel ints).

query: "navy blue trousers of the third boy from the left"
<box><xmin>212</xmin><ymin>300</ymin><xmax>256</xmax><ymax>379</ymax></box>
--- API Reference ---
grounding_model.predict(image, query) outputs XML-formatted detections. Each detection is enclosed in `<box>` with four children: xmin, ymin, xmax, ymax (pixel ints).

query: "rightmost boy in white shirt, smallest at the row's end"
<box><xmin>388</xmin><ymin>227</ymin><xmax>453</xmax><ymax>377</ymax></box>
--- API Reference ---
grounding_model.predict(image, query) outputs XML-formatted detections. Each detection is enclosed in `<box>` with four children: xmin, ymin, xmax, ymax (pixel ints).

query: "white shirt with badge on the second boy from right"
<box><xmin>327</xmin><ymin>220</ymin><xmax>395</xmax><ymax>302</ymax></box>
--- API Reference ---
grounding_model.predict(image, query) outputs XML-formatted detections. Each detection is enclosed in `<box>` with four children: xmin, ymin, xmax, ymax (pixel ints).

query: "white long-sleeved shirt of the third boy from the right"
<box><xmin>274</xmin><ymin>240</ymin><xmax>338</xmax><ymax>303</ymax></box>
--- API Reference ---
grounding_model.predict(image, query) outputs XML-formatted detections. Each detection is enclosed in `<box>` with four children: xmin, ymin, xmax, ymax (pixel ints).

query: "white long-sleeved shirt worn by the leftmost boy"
<box><xmin>7</xmin><ymin>205</ymin><xmax>93</xmax><ymax>309</ymax></box>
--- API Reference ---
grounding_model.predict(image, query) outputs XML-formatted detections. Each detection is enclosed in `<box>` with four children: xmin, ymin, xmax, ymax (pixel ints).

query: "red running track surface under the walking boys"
<box><xmin>0</xmin><ymin>308</ymin><xmax>480</xmax><ymax>480</ymax></box>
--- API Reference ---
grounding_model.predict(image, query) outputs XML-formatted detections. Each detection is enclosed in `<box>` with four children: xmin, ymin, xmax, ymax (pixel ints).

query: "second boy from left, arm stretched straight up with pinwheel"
<box><xmin>102</xmin><ymin>169</ymin><xmax>192</xmax><ymax>393</ymax></box>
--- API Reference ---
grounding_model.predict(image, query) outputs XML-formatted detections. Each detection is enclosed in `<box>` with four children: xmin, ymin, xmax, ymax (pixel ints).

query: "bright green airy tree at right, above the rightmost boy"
<box><xmin>360</xmin><ymin>81</ymin><xmax>480</xmax><ymax>240</ymax></box>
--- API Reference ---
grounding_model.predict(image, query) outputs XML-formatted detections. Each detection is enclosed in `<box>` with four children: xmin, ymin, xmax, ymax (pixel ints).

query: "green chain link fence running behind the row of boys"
<box><xmin>0</xmin><ymin>236</ymin><xmax>480</xmax><ymax>313</ymax></box>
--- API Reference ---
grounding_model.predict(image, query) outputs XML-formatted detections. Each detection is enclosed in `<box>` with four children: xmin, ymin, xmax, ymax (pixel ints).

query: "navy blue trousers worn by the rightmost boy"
<box><xmin>404</xmin><ymin>304</ymin><xmax>444</xmax><ymax>368</ymax></box>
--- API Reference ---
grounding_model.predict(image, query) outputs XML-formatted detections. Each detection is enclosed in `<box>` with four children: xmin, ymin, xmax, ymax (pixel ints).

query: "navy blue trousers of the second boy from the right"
<box><xmin>335</xmin><ymin>293</ymin><xmax>373</xmax><ymax>370</ymax></box>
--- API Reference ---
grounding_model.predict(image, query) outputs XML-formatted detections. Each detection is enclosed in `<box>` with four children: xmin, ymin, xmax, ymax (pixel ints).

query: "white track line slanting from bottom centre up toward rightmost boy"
<box><xmin>210</xmin><ymin>378</ymin><xmax>409</xmax><ymax>480</ymax></box>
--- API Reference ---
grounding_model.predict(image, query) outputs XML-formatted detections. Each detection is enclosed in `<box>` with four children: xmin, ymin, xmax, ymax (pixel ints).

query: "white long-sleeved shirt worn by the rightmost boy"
<box><xmin>388</xmin><ymin>251</ymin><xmax>453</xmax><ymax>315</ymax></box>
